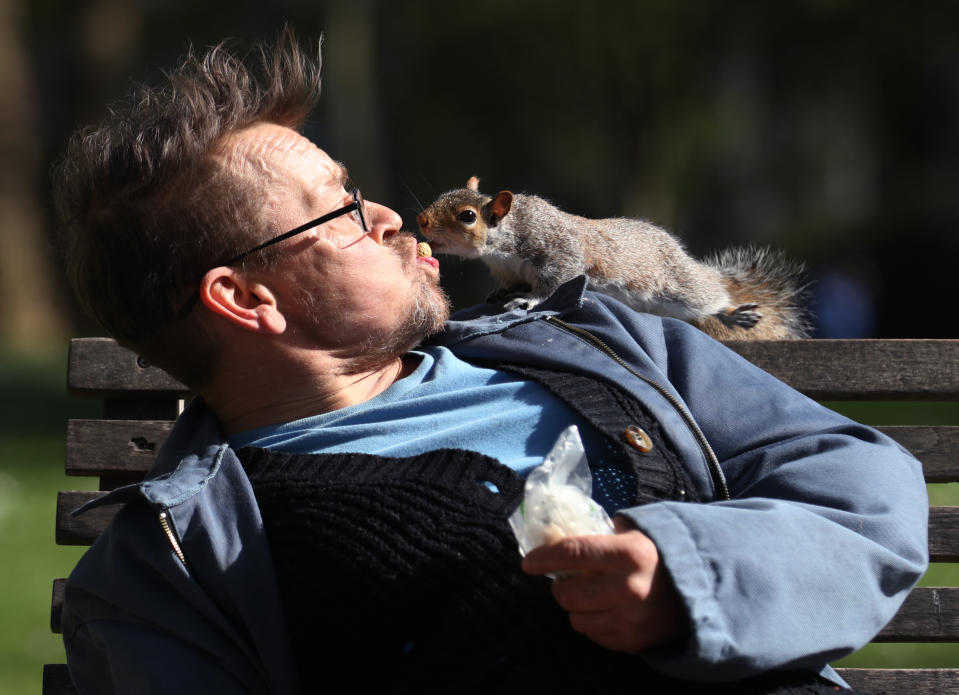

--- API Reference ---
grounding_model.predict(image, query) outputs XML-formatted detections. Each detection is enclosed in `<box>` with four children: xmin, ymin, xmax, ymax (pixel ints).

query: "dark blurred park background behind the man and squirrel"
<box><xmin>0</xmin><ymin>0</ymin><xmax>959</xmax><ymax>693</ymax></box>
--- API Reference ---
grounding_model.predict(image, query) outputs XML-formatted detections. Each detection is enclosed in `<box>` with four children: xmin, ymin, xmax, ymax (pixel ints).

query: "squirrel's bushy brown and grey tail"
<box><xmin>699</xmin><ymin>246</ymin><xmax>811</xmax><ymax>340</ymax></box>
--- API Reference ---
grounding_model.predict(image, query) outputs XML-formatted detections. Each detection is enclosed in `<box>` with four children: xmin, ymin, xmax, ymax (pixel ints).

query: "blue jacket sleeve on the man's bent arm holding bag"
<box><xmin>608</xmin><ymin>320</ymin><xmax>928</xmax><ymax>680</ymax></box>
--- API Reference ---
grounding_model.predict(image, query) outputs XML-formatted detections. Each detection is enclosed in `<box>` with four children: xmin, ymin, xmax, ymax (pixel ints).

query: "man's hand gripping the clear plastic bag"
<box><xmin>523</xmin><ymin>518</ymin><xmax>687</xmax><ymax>652</ymax></box>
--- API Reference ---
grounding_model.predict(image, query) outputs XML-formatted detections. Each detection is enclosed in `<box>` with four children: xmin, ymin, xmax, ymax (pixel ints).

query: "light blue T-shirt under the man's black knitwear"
<box><xmin>229</xmin><ymin>346</ymin><xmax>597</xmax><ymax>475</ymax></box>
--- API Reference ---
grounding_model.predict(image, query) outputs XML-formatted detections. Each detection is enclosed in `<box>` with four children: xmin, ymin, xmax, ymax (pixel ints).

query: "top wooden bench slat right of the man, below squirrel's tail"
<box><xmin>726</xmin><ymin>340</ymin><xmax>959</xmax><ymax>400</ymax></box>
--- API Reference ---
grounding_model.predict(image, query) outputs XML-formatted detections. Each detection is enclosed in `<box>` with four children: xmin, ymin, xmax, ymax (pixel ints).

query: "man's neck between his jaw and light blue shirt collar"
<box><xmin>202</xmin><ymin>355</ymin><xmax>417</xmax><ymax>435</ymax></box>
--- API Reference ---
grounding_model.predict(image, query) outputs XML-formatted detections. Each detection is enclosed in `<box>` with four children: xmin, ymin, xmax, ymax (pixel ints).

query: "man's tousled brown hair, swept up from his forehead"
<box><xmin>53</xmin><ymin>28</ymin><xmax>321</xmax><ymax>386</ymax></box>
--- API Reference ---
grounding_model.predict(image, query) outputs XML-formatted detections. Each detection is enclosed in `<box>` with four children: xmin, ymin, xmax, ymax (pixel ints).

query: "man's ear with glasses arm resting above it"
<box><xmin>200</xmin><ymin>266</ymin><xmax>286</xmax><ymax>335</ymax></box>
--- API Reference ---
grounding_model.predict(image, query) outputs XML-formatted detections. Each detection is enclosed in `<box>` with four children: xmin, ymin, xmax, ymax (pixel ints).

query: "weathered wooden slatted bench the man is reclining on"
<box><xmin>43</xmin><ymin>338</ymin><xmax>959</xmax><ymax>695</ymax></box>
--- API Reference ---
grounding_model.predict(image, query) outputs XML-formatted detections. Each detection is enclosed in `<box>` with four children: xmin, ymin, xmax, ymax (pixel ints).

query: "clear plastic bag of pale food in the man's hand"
<box><xmin>509</xmin><ymin>425</ymin><xmax>613</xmax><ymax>555</ymax></box>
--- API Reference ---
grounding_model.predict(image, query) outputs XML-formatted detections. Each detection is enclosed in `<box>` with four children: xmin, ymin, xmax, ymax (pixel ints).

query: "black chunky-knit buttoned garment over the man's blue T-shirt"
<box><xmin>238</xmin><ymin>373</ymin><xmax>868</xmax><ymax>695</ymax></box>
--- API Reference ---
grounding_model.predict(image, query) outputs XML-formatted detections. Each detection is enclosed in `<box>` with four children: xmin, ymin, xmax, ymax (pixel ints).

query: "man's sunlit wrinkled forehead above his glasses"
<box><xmin>218</xmin><ymin>123</ymin><xmax>348</xmax><ymax>189</ymax></box>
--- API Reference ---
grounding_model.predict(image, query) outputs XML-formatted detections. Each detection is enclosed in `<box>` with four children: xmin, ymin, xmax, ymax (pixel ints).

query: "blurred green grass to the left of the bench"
<box><xmin>0</xmin><ymin>352</ymin><xmax>95</xmax><ymax>695</ymax></box>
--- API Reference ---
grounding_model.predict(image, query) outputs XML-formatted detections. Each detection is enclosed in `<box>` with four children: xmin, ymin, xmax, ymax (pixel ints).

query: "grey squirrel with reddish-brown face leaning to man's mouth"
<box><xmin>416</xmin><ymin>176</ymin><xmax>809</xmax><ymax>340</ymax></box>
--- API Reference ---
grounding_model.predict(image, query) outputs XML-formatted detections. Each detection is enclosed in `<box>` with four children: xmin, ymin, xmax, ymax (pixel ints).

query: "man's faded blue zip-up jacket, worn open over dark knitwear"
<box><xmin>63</xmin><ymin>279</ymin><xmax>928</xmax><ymax>695</ymax></box>
